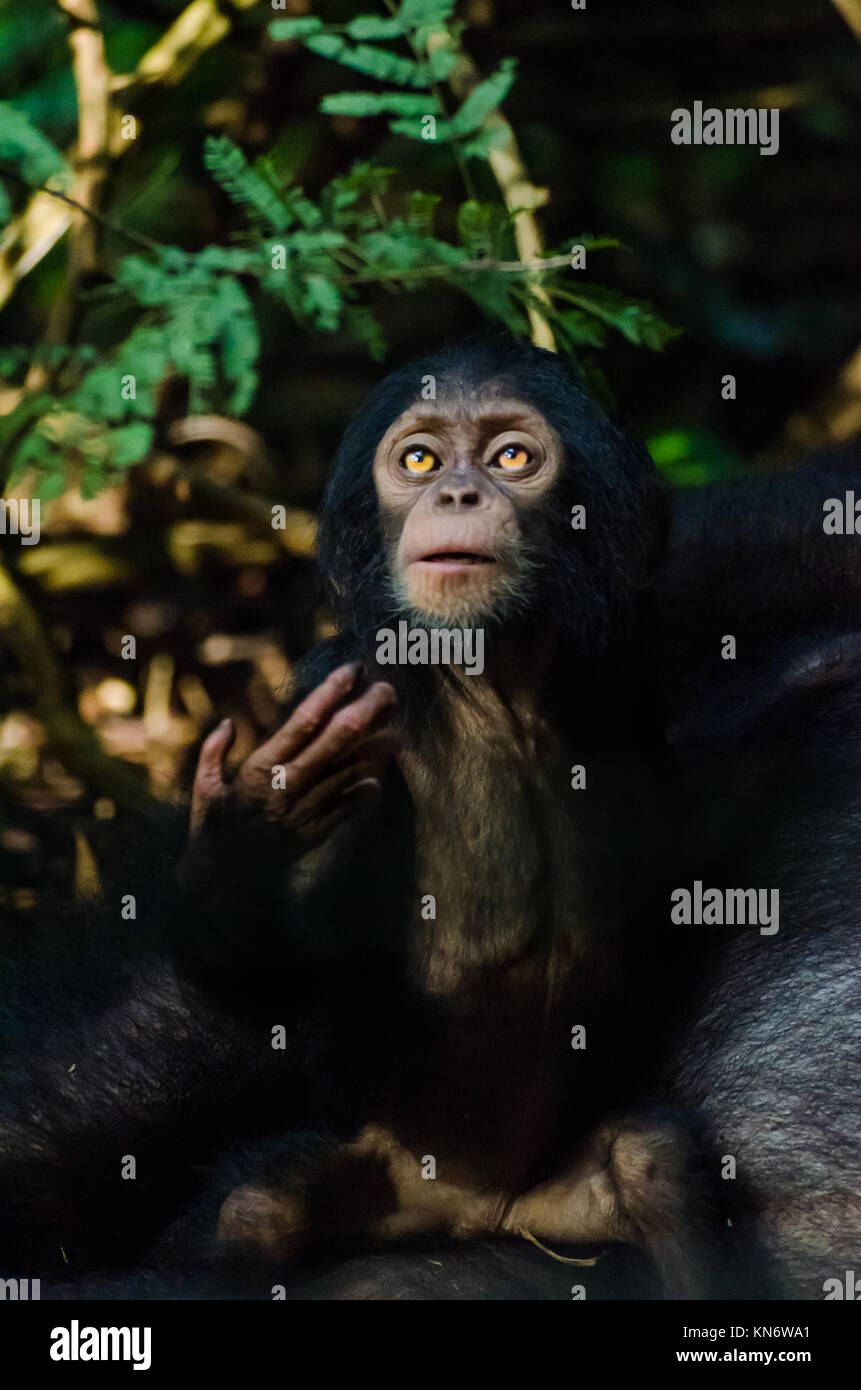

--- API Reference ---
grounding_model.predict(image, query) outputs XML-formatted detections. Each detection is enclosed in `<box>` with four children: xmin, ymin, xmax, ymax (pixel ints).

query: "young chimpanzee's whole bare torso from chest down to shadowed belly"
<box><xmin>387</xmin><ymin>722</ymin><xmax>603</xmax><ymax>1191</ymax></box>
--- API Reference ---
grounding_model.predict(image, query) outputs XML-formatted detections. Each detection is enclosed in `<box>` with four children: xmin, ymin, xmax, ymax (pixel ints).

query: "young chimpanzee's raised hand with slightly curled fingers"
<box><xmin>189</xmin><ymin>666</ymin><xmax>401</xmax><ymax>853</ymax></box>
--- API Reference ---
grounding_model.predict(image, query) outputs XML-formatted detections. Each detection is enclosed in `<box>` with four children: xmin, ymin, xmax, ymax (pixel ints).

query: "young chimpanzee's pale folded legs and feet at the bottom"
<box><xmin>218</xmin><ymin>1119</ymin><xmax>712</xmax><ymax>1298</ymax></box>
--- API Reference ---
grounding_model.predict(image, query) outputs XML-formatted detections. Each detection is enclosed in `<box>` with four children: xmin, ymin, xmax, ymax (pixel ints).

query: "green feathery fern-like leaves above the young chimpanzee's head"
<box><xmin>0</xmin><ymin>0</ymin><xmax>675</xmax><ymax>498</ymax></box>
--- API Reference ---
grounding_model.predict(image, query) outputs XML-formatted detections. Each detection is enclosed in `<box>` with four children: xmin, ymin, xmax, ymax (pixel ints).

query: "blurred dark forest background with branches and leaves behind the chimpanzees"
<box><xmin>0</xmin><ymin>0</ymin><xmax>861</xmax><ymax>945</ymax></box>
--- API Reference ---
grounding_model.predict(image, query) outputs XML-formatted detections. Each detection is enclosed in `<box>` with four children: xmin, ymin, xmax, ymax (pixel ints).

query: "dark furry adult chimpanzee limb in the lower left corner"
<box><xmin>0</xmin><ymin>962</ymin><xmax>308</xmax><ymax>1272</ymax></box>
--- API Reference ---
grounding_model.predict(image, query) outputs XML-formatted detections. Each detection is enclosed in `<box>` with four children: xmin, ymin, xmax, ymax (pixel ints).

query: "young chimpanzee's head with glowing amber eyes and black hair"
<box><xmin>317</xmin><ymin>339</ymin><xmax>666</xmax><ymax>670</ymax></box>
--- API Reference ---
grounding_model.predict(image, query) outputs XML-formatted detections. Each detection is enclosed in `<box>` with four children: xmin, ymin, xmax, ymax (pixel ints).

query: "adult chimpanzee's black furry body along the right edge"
<box><xmin>657</xmin><ymin>441</ymin><xmax>861</xmax><ymax>1298</ymax></box>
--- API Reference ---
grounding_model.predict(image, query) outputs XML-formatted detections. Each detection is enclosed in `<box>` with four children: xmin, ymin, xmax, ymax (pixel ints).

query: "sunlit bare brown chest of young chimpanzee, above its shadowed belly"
<box><xmin>403</xmin><ymin>738</ymin><xmax>588</xmax><ymax>1013</ymax></box>
